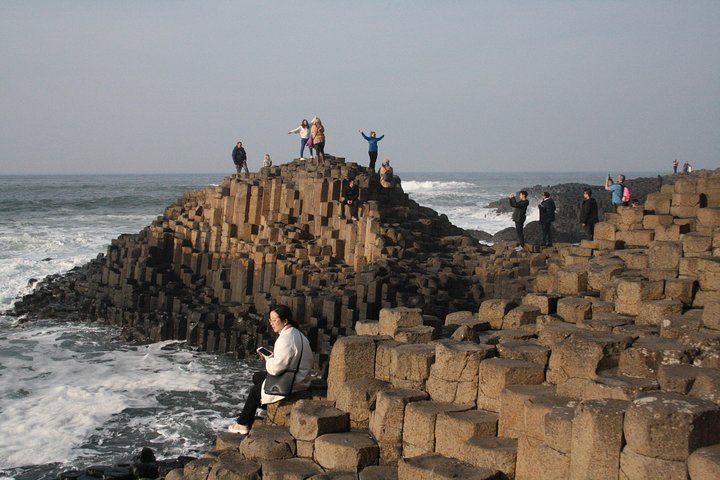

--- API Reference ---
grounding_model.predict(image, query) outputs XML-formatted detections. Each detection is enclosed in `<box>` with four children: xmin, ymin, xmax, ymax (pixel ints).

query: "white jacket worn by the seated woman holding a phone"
<box><xmin>261</xmin><ymin>325</ymin><xmax>313</xmax><ymax>405</ymax></box>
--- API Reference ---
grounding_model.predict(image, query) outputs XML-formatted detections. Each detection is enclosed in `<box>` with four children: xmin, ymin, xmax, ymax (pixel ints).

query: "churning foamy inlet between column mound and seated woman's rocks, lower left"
<box><xmin>0</xmin><ymin>322</ymin><xmax>257</xmax><ymax>473</ymax></box>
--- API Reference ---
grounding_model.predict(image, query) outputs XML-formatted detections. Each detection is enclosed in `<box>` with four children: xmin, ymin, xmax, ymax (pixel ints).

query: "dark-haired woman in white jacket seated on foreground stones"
<box><xmin>228</xmin><ymin>305</ymin><xmax>313</xmax><ymax>435</ymax></box>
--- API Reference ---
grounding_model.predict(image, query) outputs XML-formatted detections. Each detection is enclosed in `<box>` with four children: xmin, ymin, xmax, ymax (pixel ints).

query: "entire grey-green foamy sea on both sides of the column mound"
<box><xmin>0</xmin><ymin>172</ymin><xmax>657</xmax><ymax>480</ymax></box>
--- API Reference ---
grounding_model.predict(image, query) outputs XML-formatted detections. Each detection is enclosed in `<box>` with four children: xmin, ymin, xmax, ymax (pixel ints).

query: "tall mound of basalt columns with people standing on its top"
<box><xmin>15</xmin><ymin>158</ymin><xmax>496</xmax><ymax>359</ymax></box>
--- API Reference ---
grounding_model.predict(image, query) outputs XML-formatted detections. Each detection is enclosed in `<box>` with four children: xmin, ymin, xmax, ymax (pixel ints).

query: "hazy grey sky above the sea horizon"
<box><xmin>0</xmin><ymin>0</ymin><xmax>720</xmax><ymax>174</ymax></box>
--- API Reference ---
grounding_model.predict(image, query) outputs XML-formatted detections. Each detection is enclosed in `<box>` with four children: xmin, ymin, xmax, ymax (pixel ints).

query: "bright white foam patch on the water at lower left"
<box><xmin>0</xmin><ymin>325</ymin><xmax>222</xmax><ymax>469</ymax></box>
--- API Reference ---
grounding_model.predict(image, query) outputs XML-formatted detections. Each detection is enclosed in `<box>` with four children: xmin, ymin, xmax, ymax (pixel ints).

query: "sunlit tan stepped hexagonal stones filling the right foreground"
<box><xmin>168</xmin><ymin>172</ymin><xmax>720</xmax><ymax>480</ymax></box>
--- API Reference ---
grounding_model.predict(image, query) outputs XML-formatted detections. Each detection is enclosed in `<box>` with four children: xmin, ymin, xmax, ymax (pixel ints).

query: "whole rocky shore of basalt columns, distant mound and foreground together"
<box><xmin>7</xmin><ymin>159</ymin><xmax>720</xmax><ymax>480</ymax></box>
